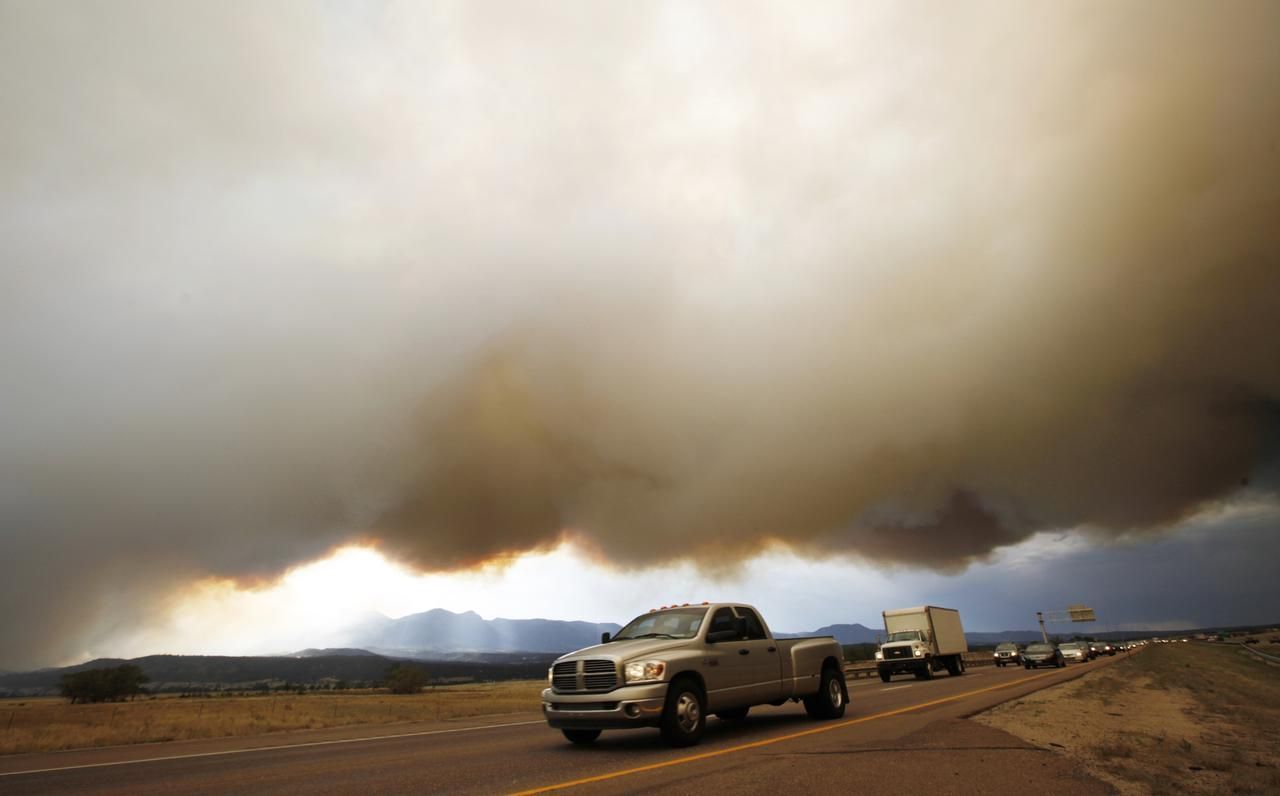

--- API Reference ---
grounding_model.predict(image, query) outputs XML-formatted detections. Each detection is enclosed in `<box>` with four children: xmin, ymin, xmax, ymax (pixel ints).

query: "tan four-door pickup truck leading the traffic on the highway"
<box><xmin>543</xmin><ymin>603</ymin><xmax>849</xmax><ymax>746</ymax></box>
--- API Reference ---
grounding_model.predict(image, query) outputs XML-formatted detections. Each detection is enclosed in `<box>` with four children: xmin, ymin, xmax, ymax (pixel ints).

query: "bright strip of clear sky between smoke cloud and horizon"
<box><xmin>92</xmin><ymin>500</ymin><xmax>1280</xmax><ymax>663</ymax></box>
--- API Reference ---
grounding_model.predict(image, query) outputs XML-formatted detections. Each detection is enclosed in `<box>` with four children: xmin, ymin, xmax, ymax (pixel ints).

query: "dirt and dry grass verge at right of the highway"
<box><xmin>975</xmin><ymin>644</ymin><xmax>1280</xmax><ymax>795</ymax></box>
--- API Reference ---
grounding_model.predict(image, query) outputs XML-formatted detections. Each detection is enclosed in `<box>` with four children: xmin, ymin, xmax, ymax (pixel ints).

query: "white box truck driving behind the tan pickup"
<box><xmin>876</xmin><ymin>605</ymin><xmax>969</xmax><ymax>682</ymax></box>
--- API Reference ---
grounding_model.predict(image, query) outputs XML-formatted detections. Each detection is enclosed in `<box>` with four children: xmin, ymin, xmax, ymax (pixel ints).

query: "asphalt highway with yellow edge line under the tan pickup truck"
<box><xmin>0</xmin><ymin>657</ymin><xmax>1124</xmax><ymax>796</ymax></box>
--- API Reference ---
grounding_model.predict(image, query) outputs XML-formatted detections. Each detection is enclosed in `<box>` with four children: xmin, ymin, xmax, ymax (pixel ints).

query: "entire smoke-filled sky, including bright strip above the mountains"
<box><xmin>0</xmin><ymin>0</ymin><xmax>1280</xmax><ymax>668</ymax></box>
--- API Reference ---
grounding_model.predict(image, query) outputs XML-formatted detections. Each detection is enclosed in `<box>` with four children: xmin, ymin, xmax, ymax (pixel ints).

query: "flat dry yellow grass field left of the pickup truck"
<box><xmin>0</xmin><ymin>681</ymin><xmax>545</xmax><ymax>754</ymax></box>
